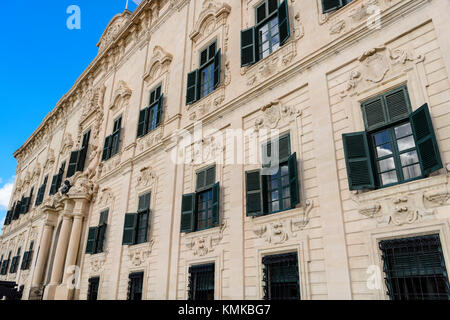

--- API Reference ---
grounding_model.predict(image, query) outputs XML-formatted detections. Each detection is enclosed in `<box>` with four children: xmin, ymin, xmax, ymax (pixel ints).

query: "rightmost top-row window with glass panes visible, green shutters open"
<box><xmin>241</xmin><ymin>0</ymin><xmax>290</xmax><ymax>67</ymax></box>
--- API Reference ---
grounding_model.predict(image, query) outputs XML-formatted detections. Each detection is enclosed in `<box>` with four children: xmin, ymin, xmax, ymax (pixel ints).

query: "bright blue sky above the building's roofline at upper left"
<box><xmin>0</xmin><ymin>0</ymin><xmax>140</xmax><ymax>227</ymax></box>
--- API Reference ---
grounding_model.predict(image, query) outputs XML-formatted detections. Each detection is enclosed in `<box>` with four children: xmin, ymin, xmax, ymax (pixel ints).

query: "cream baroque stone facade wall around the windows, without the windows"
<box><xmin>0</xmin><ymin>0</ymin><xmax>450</xmax><ymax>300</ymax></box>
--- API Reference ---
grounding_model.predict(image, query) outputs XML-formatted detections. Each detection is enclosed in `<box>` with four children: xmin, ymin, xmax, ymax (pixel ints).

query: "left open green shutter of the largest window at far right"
<box><xmin>342</xmin><ymin>131</ymin><xmax>375</xmax><ymax>190</ymax></box>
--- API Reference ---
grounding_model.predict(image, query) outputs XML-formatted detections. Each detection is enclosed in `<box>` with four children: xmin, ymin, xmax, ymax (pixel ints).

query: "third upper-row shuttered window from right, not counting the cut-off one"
<box><xmin>137</xmin><ymin>86</ymin><xmax>164</xmax><ymax>138</ymax></box>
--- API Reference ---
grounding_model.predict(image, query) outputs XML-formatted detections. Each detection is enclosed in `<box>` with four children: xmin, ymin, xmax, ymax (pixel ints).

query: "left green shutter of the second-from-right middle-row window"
<box><xmin>245</xmin><ymin>170</ymin><xmax>263</xmax><ymax>217</ymax></box>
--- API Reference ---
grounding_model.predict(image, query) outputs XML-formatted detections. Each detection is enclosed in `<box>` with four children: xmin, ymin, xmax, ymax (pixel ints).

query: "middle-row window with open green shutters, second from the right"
<box><xmin>246</xmin><ymin>134</ymin><xmax>300</xmax><ymax>217</ymax></box>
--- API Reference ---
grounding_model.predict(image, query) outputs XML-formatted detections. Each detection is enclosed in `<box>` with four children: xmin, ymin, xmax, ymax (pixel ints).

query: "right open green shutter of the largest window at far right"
<box><xmin>410</xmin><ymin>104</ymin><xmax>443</xmax><ymax>176</ymax></box>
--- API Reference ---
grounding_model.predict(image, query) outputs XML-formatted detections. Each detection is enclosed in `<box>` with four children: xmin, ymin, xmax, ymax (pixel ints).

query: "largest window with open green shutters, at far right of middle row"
<box><xmin>342</xmin><ymin>87</ymin><xmax>442</xmax><ymax>190</ymax></box>
